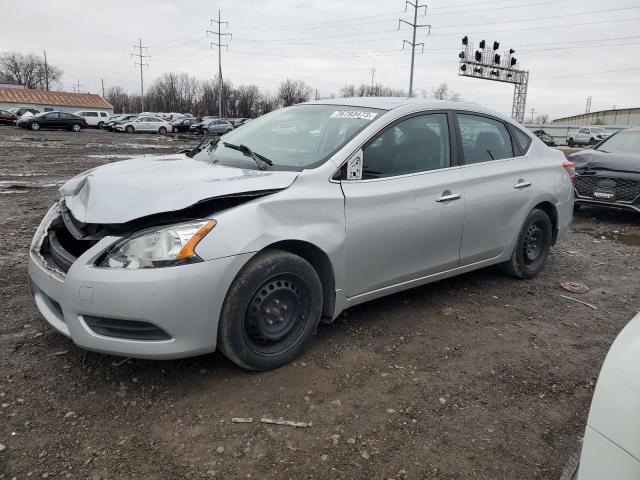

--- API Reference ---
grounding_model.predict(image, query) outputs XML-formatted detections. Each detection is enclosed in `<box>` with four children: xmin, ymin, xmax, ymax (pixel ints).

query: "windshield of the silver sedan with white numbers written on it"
<box><xmin>194</xmin><ymin>105</ymin><xmax>384</xmax><ymax>171</ymax></box>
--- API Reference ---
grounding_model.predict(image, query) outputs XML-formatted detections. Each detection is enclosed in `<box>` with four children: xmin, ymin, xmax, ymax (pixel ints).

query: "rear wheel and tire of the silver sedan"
<box><xmin>501</xmin><ymin>208</ymin><xmax>553</xmax><ymax>278</ymax></box>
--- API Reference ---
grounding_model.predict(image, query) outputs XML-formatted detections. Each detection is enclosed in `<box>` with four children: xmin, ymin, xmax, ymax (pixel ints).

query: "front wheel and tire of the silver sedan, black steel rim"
<box><xmin>218</xmin><ymin>250</ymin><xmax>322</xmax><ymax>371</ymax></box>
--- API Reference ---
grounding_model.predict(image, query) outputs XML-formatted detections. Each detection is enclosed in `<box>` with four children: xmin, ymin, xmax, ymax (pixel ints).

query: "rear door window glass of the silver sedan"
<box><xmin>458</xmin><ymin>114</ymin><xmax>513</xmax><ymax>165</ymax></box>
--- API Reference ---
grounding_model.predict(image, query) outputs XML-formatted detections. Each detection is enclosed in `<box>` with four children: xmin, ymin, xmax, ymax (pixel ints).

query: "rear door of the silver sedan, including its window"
<box><xmin>456</xmin><ymin>112</ymin><xmax>533</xmax><ymax>265</ymax></box>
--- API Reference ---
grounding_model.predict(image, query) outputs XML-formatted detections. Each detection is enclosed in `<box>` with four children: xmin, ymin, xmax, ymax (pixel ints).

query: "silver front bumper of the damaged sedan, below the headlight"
<box><xmin>28</xmin><ymin>205</ymin><xmax>251</xmax><ymax>359</ymax></box>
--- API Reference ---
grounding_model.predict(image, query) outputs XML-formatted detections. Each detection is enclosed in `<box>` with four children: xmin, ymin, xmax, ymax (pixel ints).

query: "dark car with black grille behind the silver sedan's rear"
<box><xmin>569</xmin><ymin>127</ymin><xmax>640</xmax><ymax>212</ymax></box>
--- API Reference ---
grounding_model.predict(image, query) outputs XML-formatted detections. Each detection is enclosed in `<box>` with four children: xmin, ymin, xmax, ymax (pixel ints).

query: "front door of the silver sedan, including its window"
<box><xmin>341</xmin><ymin>113</ymin><xmax>464</xmax><ymax>297</ymax></box>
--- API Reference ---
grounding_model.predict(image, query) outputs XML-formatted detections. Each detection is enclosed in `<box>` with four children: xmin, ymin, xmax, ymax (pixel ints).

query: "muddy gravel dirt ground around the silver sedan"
<box><xmin>0</xmin><ymin>127</ymin><xmax>640</xmax><ymax>480</ymax></box>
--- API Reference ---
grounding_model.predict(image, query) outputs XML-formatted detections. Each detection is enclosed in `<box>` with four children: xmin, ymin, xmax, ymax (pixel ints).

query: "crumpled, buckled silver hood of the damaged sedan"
<box><xmin>59</xmin><ymin>154</ymin><xmax>298</xmax><ymax>224</ymax></box>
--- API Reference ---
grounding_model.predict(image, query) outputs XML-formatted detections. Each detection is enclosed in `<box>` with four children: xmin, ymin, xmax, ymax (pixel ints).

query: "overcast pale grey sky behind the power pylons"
<box><xmin>0</xmin><ymin>0</ymin><xmax>640</xmax><ymax>120</ymax></box>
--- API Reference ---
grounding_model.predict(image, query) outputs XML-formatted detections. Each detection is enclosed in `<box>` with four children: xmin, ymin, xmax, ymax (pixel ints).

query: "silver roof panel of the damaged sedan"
<box><xmin>303</xmin><ymin>97</ymin><xmax>508</xmax><ymax>123</ymax></box>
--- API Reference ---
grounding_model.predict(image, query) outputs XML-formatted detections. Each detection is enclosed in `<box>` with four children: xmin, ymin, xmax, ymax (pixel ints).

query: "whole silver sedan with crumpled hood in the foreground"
<box><xmin>29</xmin><ymin>98</ymin><xmax>573</xmax><ymax>370</ymax></box>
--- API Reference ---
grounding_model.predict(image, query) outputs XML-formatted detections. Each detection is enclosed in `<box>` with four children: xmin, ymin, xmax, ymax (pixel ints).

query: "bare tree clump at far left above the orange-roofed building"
<box><xmin>0</xmin><ymin>52</ymin><xmax>62</xmax><ymax>88</ymax></box>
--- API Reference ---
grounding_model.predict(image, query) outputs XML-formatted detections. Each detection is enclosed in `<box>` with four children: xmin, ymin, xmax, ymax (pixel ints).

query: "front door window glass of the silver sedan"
<box><xmin>362</xmin><ymin>113</ymin><xmax>449</xmax><ymax>179</ymax></box>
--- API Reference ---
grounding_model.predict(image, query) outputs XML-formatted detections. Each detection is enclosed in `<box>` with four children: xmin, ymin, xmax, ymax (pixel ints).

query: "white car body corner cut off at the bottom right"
<box><xmin>561</xmin><ymin>314</ymin><xmax>640</xmax><ymax>480</ymax></box>
